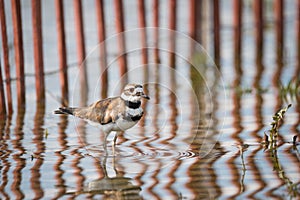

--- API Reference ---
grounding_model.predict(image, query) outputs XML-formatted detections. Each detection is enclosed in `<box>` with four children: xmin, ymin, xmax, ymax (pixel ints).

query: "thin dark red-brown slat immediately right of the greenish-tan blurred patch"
<box><xmin>213</xmin><ymin>0</ymin><xmax>220</xmax><ymax>67</ymax></box>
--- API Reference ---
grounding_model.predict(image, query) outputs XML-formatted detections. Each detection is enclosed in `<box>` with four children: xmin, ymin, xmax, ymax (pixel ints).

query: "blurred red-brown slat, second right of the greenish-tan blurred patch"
<box><xmin>233</xmin><ymin>0</ymin><xmax>243</xmax><ymax>62</ymax></box>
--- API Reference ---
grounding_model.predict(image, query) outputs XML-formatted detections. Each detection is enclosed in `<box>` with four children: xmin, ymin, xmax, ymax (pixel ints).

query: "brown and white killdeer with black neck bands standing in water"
<box><xmin>54</xmin><ymin>84</ymin><xmax>150</xmax><ymax>153</ymax></box>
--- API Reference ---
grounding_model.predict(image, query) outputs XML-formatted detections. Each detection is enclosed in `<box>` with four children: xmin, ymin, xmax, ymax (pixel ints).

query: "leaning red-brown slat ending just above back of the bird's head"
<box><xmin>114</xmin><ymin>0</ymin><xmax>127</xmax><ymax>81</ymax></box>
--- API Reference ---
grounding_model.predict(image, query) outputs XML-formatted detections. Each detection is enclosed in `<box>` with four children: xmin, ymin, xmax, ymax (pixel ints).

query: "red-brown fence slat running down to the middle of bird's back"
<box><xmin>95</xmin><ymin>0</ymin><xmax>108</xmax><ymax>98</ymax></box>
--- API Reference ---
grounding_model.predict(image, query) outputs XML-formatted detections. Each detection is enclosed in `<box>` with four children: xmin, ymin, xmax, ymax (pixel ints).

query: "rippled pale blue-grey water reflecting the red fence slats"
<box><xmin>0</xmin><ymin>1</ymin><xmax>300</xmax><ymax>199</ymax></box>
